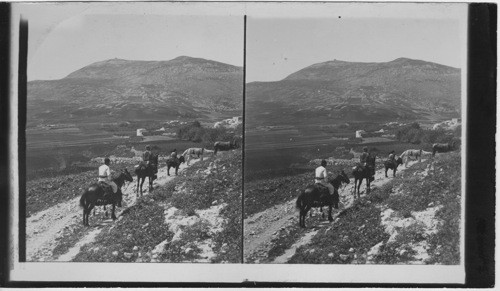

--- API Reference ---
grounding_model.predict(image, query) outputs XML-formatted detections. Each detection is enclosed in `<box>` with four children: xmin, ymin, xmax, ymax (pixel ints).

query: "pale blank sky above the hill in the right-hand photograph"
<box><xmin>246</xmin><ymin>17</ymin><xmax>466</xmax><ymax>82</ymax></box>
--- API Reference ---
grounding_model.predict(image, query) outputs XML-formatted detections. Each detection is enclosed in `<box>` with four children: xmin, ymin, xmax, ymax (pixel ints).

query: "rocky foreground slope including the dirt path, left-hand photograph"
<box><xmin>26</xmin><ymin>151</ymin><xmax>242</xmax><ymax>263</ymax></box>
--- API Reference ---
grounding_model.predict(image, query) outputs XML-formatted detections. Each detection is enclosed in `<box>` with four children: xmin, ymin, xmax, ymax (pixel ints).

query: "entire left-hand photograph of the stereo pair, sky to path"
<box><xmin>20</xmin><ymin>3</ymin><xmax>244</xmax><ymax>263</ymax></box>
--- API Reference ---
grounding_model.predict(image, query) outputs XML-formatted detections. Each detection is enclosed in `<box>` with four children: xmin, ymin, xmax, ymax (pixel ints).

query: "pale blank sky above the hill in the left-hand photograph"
<box><xmin>18</xmin><ymin>3</ymin><xmax>243</xmax><ymax>81</ymax></box>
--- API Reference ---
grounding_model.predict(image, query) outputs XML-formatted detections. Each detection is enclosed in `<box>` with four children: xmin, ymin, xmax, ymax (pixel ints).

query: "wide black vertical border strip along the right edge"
<box><xmin>465</xmin><ymin>3</ymin><xmax>497</xmax><ymax>288</ymax></box>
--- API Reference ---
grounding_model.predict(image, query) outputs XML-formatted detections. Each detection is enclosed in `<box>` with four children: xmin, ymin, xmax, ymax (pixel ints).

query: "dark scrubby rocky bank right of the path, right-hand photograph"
<box><xmin>289</xmin><ymin>152</ymin><xmax>461</xmax><ymax>265</ymax></box>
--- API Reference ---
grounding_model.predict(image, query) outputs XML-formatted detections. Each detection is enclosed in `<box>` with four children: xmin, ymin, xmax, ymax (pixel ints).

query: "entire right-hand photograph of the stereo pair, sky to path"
<box><xmin>243</xmin><ymin>7</ymin><xmax>467</xmax><ymax>265</ymax></box>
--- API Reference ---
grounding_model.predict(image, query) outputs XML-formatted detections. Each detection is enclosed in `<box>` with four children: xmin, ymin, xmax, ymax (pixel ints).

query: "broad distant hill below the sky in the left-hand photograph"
<box><xmin>28</xmin><ymin>56</ymin><xmax>243</xmax><ymax>122</ymax></box>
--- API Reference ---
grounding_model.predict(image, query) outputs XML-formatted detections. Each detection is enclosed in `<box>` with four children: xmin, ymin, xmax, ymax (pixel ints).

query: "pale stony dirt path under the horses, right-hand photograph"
<box><xmin>243</xmin><ymin>160</ymin><xmax>424</xmax><ymax>263</ymax></box>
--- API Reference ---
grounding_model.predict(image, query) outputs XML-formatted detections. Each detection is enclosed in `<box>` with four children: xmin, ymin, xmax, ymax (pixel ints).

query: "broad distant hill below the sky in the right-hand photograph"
<box><xmin>246</xmin><ymin>58</ymin><xmax>461</xmax><ymax>125</ymax></box>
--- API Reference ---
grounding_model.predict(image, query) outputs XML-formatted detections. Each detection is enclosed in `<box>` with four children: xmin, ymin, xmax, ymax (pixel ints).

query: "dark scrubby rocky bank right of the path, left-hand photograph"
<box><xmin>73</xmin><ymin>151</ymin><xmax>242</xmax><ymax>263</ymax></box>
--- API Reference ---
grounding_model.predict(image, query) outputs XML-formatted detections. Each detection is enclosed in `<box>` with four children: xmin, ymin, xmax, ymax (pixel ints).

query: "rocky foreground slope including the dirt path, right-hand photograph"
<box><xmin>244</xmin><ymin>152</ymin><xmax>461</xmax><ymax>264</ymax></box>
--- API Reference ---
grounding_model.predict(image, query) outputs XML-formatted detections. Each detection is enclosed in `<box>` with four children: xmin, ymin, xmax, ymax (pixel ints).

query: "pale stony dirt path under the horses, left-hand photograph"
<box><xmin>26</xmin><ymin>159</ymin><xmax>198</xmax><ymax>262</ymax></box>
